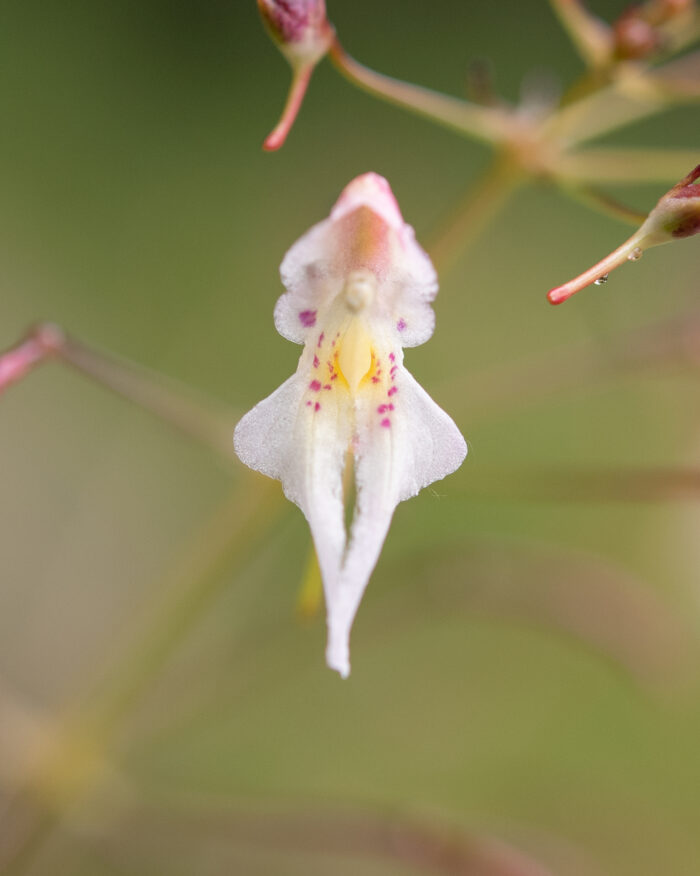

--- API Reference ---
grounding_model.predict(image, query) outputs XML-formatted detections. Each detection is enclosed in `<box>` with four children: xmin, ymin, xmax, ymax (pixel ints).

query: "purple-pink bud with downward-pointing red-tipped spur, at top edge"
<box><xmin>258</xmin><ymin>0</ymin><xmax>334</xmax><ymax>152</ymax></box>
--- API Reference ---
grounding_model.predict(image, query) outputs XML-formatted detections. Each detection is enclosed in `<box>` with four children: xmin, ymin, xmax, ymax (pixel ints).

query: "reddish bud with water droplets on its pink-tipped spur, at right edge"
<box><xmin>547</xmin><ymin>164</ymin><xmax>700</xmax><ymax>304</ymax></box>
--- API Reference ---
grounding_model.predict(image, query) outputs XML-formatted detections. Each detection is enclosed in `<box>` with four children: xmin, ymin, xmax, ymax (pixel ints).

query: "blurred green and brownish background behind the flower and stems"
<box><xmin>0</xmin><ymin>0</ymin><xmax>700</xmax><ymax>876</ymax></box>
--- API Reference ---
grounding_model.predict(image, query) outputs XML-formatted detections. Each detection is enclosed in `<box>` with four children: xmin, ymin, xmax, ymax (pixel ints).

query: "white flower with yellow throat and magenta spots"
<box><xmin>234</xmin><ymin>173</ymin><xmax>467</xmax><ymax>678</ymax></box>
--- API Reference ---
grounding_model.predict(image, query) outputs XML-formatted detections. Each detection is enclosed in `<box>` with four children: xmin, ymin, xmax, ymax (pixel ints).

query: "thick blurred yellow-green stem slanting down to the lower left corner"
<box><xmin>0</xmin><ymin>475</ymin><xmax>286</xmax><ymax>874</ymax></box>
